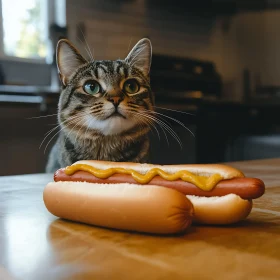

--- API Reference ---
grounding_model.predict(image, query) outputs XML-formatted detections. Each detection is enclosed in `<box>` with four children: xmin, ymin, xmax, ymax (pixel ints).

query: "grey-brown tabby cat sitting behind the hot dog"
<box><xmin>46</xmin><ymin>38</ymin><xmax>155</xmax><ymax>173</ymax></box>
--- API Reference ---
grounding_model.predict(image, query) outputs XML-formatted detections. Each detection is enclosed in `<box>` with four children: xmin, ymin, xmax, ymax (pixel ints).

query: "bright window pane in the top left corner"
<box><xmin>2</xmin><ymin>0</ymin><xmax>48</xmax><ymax>59</ymax></box>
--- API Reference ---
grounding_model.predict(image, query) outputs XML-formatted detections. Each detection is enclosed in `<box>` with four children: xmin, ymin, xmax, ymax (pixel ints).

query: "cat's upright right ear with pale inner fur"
<box><xmin>125</xmin><ymin>38</ymin><xmax>152</xmax><ymax>76</ymax></box>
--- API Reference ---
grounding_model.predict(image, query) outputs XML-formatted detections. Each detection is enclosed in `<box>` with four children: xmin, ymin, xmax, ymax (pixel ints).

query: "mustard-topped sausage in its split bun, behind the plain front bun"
<box><xmin>46</xmin><ymin>160</ymin><xmax>265</xmax><ymax>228</ymax></box>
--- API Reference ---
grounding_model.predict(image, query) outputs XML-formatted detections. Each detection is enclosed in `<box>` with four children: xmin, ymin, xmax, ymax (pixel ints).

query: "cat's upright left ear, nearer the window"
<box><xmin>56</xmin><ymin>39</ymin><xmax>87</xmax><ymax>86</ymax></box>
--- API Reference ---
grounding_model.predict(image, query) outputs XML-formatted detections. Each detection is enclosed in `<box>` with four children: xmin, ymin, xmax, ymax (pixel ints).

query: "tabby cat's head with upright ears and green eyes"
<box><xmin>57</xmin><ymin>39</ymin><xmax>154</xmax><ymax>135</ymax></box>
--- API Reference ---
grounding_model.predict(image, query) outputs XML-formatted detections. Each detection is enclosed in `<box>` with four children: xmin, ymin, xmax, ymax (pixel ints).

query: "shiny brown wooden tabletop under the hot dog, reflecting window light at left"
<box><xmin>0</xmin><ymin>159</ymin><xmax>280</xmax><ymax>280</ymax></box>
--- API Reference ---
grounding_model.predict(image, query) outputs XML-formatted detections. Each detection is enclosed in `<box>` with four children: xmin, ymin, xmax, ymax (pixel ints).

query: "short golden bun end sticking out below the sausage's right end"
<box><xmin>187</xmin><ymin>194</ymin><xmax>253</xmax><ymax>225</ymax></box>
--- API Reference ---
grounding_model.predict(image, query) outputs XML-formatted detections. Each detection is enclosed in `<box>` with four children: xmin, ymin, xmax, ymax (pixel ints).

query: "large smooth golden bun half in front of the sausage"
<box><xmin>43</xmin><ymin>182</ymin><xmax>193</xmax><ymax>234</ymax></box>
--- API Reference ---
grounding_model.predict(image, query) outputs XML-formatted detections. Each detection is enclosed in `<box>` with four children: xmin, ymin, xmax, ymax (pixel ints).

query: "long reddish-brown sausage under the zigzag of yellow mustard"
<box><xmin>54</xmin><ymin>168</ymin><xmax>265</xmax><ymax>199</ymax></box>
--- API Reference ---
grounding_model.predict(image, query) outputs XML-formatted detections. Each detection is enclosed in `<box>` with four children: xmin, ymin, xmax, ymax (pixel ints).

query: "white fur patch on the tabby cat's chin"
<box><xmin>85</xmin><ymin>116</ymin><xmax>136</xmax><ymax>136</ymax></box>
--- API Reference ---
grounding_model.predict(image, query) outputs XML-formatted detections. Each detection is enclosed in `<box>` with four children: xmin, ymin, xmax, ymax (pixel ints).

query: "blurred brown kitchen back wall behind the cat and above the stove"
<box><xmin>67</xmin><ymin>0</ymin><xmax>280</xmax><ymax>101</ymax></box>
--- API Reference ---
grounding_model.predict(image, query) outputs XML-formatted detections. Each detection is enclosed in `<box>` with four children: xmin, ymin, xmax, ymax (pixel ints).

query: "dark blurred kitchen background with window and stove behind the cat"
<box><xmin>0</xmin><ymin>0</ymin><xmax>280</xmax><ymax>175</ymax></box>
